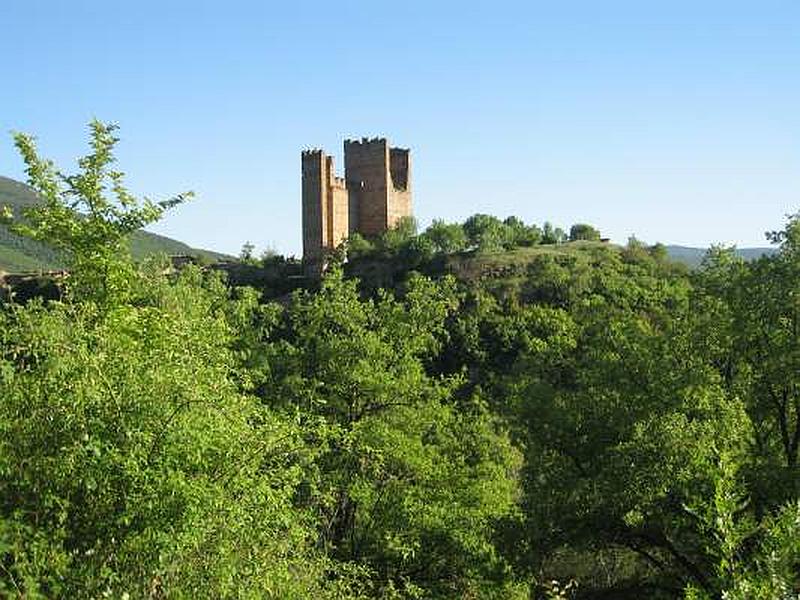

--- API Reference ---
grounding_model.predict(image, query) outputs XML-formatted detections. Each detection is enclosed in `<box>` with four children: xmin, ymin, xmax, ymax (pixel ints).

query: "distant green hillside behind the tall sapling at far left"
<box><xmin>0</xmin><ymin>176</ymin><xmax>229</xmax><ymax>273</ymax></box>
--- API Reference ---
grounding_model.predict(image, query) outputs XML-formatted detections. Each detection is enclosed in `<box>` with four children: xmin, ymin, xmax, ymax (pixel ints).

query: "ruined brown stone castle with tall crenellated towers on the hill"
<box><xmin>302</xmin><ymin>138</ymin><xmax>411</xmax><ymax>263</ymax></box>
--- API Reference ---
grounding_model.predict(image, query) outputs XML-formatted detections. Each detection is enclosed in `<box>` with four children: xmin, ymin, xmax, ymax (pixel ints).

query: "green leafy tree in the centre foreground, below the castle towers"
<box><xmin>253</xmin><ymin>270</ymin><xmax>518</xmax><ymax>598</ymax></box>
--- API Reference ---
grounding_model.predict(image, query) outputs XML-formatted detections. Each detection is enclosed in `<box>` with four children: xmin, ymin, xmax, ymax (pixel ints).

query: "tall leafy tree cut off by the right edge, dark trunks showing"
<box><xmin>698</xmin><ymin>215</ymin><xmax>800</xmax><ymax>500</ymax></box>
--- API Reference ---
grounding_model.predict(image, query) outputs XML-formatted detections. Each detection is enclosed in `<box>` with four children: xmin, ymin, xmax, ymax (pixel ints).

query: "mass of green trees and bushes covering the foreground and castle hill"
<box><xmin>0</xmin><ymin>123</ymin><xmax>800</xmax><ymax>600</ymax></box>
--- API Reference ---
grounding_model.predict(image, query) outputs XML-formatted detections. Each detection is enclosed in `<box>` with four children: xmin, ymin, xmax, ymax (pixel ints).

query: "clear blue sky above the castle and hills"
<box><xmin>0</xmin><ymin>0</ymin><xmax>800</xmax><ymax>254</ymax></box>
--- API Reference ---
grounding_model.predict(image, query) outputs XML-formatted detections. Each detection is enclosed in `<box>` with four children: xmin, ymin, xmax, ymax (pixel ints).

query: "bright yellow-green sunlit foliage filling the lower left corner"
<box><xmin>0</xmin><ymin>269</ymin><xmax>356</xmax><ymax>598</ymax></box>
